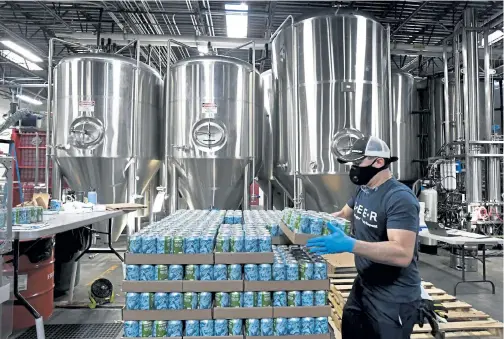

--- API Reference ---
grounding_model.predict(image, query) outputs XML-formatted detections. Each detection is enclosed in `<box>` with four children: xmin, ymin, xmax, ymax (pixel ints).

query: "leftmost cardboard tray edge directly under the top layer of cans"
<box><xmin>124</xmin><ymin>253</ymin><xmax>214</xmax><ymax>265</ymax></box>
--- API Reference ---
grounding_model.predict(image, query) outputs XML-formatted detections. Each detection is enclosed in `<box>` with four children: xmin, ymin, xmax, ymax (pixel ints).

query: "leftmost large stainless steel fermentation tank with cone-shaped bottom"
<box><xmin>53</xmin><ymin>54</ymin><xmax>163</xmax><ymax>240</ymax></box>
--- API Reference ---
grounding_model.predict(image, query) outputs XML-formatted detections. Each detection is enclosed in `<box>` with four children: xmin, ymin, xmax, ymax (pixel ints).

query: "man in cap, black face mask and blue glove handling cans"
<box><xmin>307</xmin><ymin>137</ymin><xmax>421</xmax><ymax>339</ymax></box>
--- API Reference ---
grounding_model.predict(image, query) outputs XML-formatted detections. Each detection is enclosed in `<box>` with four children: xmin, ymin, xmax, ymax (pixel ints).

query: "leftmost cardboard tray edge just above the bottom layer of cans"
<box><xmin>123</xmin><ymin>309</ymin><xmax>213</xmax><ymax>321</ymax></box>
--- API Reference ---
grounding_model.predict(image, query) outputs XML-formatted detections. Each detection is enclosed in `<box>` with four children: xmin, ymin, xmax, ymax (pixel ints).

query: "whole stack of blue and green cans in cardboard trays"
<box><xmin>123</xmin><ymin>210</ymin><xmax>330</xmax><ymax>339</ymax></box>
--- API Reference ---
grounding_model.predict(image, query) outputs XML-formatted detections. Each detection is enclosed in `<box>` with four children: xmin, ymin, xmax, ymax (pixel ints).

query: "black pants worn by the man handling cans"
<box><xmin>341</xmin><ymin>277</ymin><xmax>420</xmax><ymax>339</ymax></box>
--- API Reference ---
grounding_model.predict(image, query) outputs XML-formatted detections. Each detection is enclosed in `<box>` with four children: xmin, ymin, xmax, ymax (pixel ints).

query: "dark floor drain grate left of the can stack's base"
<box><xmin>16</xmin><ymin>323</ymin><xmax>122</xmax><ymax>339</ymax></box>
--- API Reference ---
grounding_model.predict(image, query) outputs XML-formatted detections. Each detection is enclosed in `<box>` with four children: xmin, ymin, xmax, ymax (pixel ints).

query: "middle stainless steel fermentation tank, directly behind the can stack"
<box><xmin>167</xmin><ymin>55</ymin><xmax>263</xmax><ymax>209</ymax></box>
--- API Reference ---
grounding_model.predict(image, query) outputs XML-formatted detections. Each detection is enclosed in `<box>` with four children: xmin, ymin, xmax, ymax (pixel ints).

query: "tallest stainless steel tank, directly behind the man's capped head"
<box><xmin>272</xmin><ymin>9</ymin><xmax>391</xmax><ymax>211</ymax></box>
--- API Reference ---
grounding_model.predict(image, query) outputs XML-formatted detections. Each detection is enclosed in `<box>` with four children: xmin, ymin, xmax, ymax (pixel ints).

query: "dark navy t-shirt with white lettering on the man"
<box><xmin>347</xmin><ymin>178</ymin><xmax>420</xmax><ymax>303</ymax></box>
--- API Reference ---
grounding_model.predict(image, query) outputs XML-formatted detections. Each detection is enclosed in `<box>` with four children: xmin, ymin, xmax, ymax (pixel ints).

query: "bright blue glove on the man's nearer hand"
<box><xmin>306</xmin><ymin>223</ymin><xmax>356</xmax><ymax>255</ymax></box>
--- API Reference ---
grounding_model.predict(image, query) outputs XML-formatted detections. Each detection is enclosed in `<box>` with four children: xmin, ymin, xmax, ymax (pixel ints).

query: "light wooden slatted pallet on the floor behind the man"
<box><xmin>329</xmin><ymin>272</ymin><xmax>504</xmax><ymax>339</ymax></box>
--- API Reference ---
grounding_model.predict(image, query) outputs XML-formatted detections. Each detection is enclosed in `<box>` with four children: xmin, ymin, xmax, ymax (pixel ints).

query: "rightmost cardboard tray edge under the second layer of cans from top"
<box><xmin>243</xmin><ymin>279</ymin><xmax>329</xmax><ymax>291</ymax></box>
